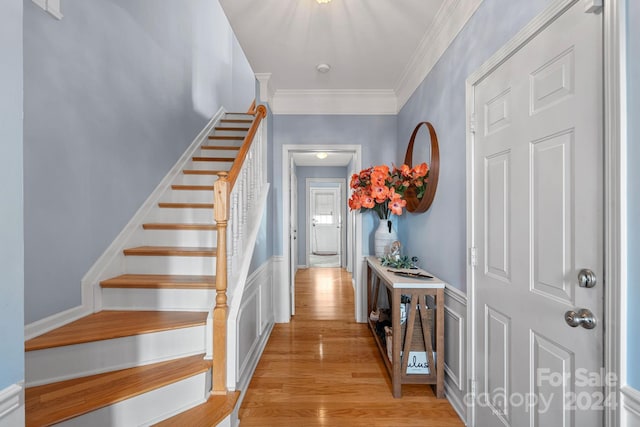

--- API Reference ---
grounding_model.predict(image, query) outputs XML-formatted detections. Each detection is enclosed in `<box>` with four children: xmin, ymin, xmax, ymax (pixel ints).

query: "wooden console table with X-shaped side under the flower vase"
<box><xmin>367</xmin><ymin>256</ymin><xmax>445</xmax><ymax>399</ymax></box>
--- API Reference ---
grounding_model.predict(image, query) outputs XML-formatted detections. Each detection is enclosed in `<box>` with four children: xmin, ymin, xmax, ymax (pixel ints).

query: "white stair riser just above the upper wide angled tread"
<box><xmin>102</xmin><ymin>288</ymin><xmax>215</xmax><ymax>311</ymax></box>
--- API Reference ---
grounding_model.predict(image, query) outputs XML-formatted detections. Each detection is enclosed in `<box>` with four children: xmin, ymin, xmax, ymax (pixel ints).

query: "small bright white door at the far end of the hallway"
<box><xmin>309</xmin><ymin>188</ymin><xmax>342</xmax><ymax>255</ymax></box>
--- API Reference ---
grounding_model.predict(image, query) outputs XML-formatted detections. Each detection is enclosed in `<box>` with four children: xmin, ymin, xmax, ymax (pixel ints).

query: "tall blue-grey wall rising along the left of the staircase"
<box><xmin>24</xmin><ymin>0</ymin><xmax>255</xmax><ymax>323</ymax></box>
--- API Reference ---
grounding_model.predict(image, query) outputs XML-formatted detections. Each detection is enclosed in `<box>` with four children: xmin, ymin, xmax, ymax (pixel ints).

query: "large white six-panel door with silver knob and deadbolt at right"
<box><xmin>472</xmin><ymin>2</ymin><xmax>606</xmax><ymax>427</ymax></box>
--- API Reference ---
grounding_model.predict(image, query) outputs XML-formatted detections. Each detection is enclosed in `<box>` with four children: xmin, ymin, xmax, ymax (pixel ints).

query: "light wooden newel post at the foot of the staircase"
<box><xmin>211</xmin><ymin>172</ymin><xmax>230</xmax><ymax>394</ymax></box>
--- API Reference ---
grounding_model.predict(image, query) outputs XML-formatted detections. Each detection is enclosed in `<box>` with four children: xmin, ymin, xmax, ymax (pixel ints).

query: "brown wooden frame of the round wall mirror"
<box><xmin>404</xmin><ymin>122</ymin><xmax>440</xmax><ymax>213</ymax></box>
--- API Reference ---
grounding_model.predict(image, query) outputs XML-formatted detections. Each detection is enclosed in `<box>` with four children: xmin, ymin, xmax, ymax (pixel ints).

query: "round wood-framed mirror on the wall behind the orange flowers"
<box><xmin>404</xmin><ymin>122</ymin><xmax>440</xmax><ymax>213</ymax></box>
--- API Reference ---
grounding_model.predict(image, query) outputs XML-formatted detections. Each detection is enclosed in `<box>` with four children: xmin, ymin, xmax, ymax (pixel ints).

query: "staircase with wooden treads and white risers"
<box><xmin>25</xmin><ymin>109</ymin><xmax>261</xmax><ymax>427</ymax></box>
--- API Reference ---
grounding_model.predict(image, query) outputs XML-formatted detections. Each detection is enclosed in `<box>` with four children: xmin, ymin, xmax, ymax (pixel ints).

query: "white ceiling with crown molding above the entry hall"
<box><xmin>220</xmin><ymin>0</ymin><xmax>482</xmax><ymax>114</ymax></box>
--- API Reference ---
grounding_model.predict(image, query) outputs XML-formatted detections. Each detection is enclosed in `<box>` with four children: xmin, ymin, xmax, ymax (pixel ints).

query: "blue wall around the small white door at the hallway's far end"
<box><xmin>296</xmin><ymin>166</ymin><xmax>349</xmax><ymax>265</ymax></box>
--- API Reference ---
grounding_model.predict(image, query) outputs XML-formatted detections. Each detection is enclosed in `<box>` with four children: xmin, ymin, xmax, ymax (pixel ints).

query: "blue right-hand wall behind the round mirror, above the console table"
<box><xmin>396</xmin><ymin>0</ymin><xmax>550</xmax><ymax>291</ymax></box>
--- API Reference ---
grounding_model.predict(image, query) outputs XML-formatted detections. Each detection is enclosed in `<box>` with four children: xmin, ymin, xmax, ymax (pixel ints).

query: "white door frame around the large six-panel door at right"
<box><xmin>465</xmin><ymin>0</ymin><xmax>626</xmax><ymax>427</ymax></box>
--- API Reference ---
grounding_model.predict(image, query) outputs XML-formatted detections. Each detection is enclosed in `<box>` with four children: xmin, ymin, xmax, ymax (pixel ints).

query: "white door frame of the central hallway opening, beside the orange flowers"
<box><xmin>282</xmin><ymin>144</ymin><xmax>367</xmax><ymax>323</ymax></box>
